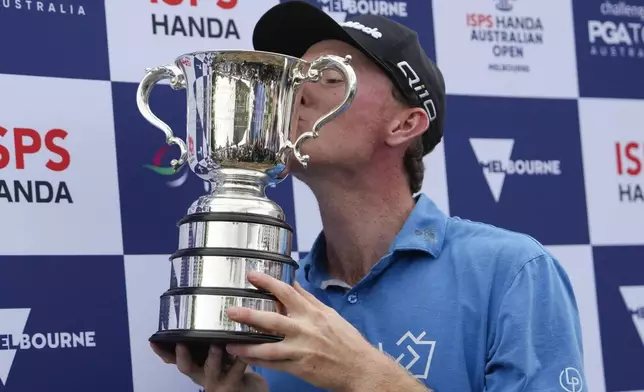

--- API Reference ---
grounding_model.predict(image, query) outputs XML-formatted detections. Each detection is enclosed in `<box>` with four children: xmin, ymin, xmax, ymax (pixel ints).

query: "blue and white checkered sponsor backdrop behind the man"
<box><xmin>0</xmin><ymin>0</ymin><xmax>644</xmax><ymax>392</ymax></box>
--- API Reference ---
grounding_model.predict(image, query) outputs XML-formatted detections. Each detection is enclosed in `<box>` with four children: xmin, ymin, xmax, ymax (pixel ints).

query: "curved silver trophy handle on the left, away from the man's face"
<box><xmin>136</xmin><ymin>65</ymin><xmax>188</xmax><ymax>171</ymax></box>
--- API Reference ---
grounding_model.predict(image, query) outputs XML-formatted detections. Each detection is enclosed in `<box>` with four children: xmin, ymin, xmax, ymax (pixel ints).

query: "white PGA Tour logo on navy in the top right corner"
<box><xmin>588</xmin><ymin>1</ymin><xmax>644</xmax><ymax>59</ymax></box>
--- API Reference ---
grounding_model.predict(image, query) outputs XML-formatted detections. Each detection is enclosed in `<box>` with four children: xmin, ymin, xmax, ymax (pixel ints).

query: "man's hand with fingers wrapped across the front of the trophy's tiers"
<box><xmin>226</xmin><ymin>272</ymin><xmax>426</xmax><ymax>392</ymax></box>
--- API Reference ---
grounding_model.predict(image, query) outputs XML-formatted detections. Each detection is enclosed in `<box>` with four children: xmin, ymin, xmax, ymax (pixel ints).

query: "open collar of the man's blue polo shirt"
<box><xmin>301</xmin><ymin>193</ymin><xmax>447</xmax><ymax>287</ymax></box>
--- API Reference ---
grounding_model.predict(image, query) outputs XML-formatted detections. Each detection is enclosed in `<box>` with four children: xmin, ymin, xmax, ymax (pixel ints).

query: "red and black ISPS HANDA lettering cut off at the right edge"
<box><xmin>615</xmin><ymin>140</ymin><xmax>644</xmax><ymax>203</ymax></box>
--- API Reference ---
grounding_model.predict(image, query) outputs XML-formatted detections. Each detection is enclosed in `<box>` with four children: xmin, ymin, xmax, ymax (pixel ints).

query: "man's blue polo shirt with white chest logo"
<box><xmin>256</xmin><ymin>194</ymin><xmax>589</xmax><ymax>392</ymax></box>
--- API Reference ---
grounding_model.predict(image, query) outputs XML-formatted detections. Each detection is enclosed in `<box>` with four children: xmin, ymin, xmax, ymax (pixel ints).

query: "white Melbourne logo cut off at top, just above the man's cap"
<box><xmin>318</xmin><ymin>0</ymin><xmax>407</xmax><ymax>22</ymax></box>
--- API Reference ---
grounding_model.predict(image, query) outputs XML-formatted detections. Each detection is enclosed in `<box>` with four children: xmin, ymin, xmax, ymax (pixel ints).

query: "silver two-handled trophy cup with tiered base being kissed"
<box><xmin>137</xmin><ymin>50</ymin><xmax>357</xmax><ymax>361</ymax></box>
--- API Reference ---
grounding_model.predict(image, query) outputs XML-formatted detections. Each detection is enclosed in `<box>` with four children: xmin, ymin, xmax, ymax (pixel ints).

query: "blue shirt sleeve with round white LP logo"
<box><xmin>484</xmin><ymin>255</ymin><xmax>588</xmax><ymax>392</ymax></box>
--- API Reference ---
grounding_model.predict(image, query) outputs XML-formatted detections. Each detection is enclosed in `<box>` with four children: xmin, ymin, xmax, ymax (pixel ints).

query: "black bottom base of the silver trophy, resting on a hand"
<box><xmin>148</xmin><ymin>330</ymin><xmax>283</xmax><ymax>366</ymax></box>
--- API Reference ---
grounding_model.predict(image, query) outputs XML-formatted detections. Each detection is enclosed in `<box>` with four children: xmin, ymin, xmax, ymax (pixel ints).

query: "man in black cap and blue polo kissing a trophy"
<box><xmin>155</xmin><ymin>2</ymin><xmax>587</xmax><ymax>392</ymax></box>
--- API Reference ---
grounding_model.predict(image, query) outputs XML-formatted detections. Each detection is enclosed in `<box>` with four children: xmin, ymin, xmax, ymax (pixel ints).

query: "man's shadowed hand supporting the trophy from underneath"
<box><xmin>152</xmin><ymin>344</ymin><xmax>268</xmax><ymax>392</ymax></box>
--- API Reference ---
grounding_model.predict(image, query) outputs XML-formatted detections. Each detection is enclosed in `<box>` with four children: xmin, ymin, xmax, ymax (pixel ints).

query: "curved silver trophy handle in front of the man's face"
<box><xmin>292</xmin><ymin>55</ymin><xmax>358</xmax><ymax>168</ymax></box>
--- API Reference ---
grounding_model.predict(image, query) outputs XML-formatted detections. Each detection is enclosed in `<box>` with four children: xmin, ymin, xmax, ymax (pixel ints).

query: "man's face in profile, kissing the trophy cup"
<box><xmin>289</xmin><ymin>41</ymin><xmax>400</xmax><ymax>178</ymax></box>
